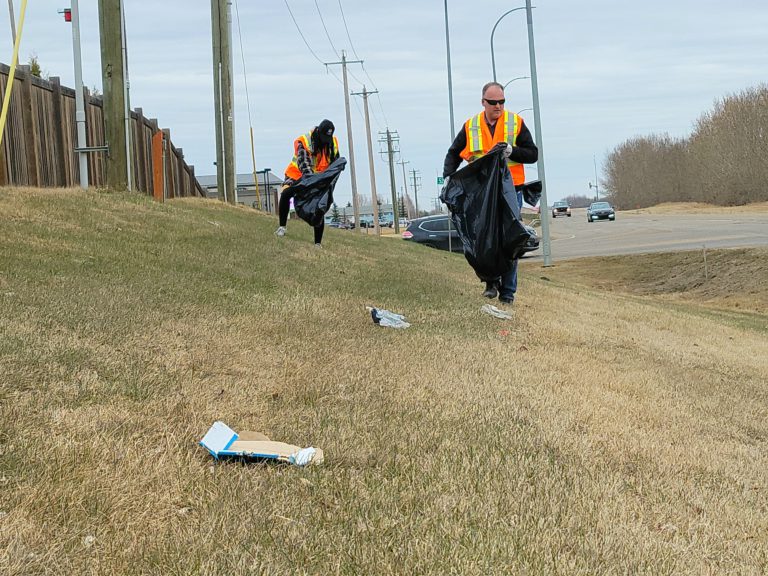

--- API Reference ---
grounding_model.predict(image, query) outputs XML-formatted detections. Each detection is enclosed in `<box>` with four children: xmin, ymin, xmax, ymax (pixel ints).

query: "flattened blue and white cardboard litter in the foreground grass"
<box><xmin>200</xmin><ymin>421</ymin><xmax>323</xmax><ymax>466</ymax></box>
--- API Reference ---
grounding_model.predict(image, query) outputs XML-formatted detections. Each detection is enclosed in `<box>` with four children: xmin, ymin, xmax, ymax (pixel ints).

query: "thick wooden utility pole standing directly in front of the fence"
<box><xmin>99</xmin><ymin>0</ymin><xmax>128</xmax><ymax>189</ymax></box>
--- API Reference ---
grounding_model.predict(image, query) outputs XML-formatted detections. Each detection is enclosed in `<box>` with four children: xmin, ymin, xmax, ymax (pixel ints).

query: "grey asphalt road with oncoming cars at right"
<box><xmin>526</xmin><ymin>209</ymin><xmax>768</xmax><ymax>261</ymax></box>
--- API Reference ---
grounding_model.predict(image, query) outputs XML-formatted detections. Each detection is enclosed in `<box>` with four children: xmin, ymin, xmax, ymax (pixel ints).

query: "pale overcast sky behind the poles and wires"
<box><xmin>0</xmin><ymin>0</ymin><xmax>768</xmax><ymax>207</ymax></box>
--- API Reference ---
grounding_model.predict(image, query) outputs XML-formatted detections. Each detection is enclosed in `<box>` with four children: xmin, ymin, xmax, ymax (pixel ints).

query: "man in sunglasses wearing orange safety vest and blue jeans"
<box><xmin>443</xmin><ymin>82</ymin><xmax>539</xmax><ymax>304</ymax></box>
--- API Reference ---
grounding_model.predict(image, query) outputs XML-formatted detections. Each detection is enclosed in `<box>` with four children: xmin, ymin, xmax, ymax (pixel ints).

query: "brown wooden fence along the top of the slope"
<box><xmin>0</xmin><ymin>64</ymin><xmax>205</xmax><ymax>200</ymax></box>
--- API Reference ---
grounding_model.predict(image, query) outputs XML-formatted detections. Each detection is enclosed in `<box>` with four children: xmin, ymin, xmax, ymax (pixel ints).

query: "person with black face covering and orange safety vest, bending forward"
<box><xmin>275</xmin><ymin>120</ymin><xmax>339</xmax><ymax>248</ymax></box>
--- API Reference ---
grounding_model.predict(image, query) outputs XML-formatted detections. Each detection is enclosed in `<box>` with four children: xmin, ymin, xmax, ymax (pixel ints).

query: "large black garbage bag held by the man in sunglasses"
<box><xmin>440</xmin><ymin>147</ymin><xmax>529</xmax><ymax>282</ymax></box>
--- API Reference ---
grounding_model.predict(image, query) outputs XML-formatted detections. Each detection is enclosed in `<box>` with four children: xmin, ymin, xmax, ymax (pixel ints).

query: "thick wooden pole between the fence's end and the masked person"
<box><xmin>211</xmin><ymin>0</ymin><xmax>237</xmax><ymax>204</ymax></box>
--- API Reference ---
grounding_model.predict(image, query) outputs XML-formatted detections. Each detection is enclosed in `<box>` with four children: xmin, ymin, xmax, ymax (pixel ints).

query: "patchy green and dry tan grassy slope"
<box><xmin>0</xmin><ymin>190</ymin><xmax>768</xmax><ymax>574</ymax></box>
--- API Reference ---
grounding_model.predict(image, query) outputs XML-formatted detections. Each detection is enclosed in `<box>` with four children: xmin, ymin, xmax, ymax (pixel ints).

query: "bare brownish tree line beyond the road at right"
<box><xmin>603</xmin><ymin>85</ymin><xmax>768</xmax><ymax>209</ymax></box>
